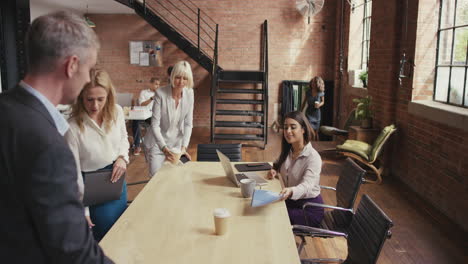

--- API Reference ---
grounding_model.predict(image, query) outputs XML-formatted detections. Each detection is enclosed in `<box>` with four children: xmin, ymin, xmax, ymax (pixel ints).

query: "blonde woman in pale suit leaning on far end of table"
<box><xmin>143</xmin><ymin>61</ymin><xmax>194</xmax><ymax>177</ymax></box>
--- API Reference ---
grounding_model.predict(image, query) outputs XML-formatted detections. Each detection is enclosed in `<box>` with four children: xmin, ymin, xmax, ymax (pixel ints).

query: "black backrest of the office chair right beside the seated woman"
<box><xmin>330</xmin><ymin>158</ymin><xmax>366</xmax><ymax>229</ymax></box>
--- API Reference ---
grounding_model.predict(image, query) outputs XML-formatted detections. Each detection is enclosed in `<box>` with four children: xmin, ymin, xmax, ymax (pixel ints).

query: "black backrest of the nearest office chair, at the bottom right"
<box><xmin>344</xmin><ymin>195</ymin><xmax>393</xmax><ymax>264</ymax></box>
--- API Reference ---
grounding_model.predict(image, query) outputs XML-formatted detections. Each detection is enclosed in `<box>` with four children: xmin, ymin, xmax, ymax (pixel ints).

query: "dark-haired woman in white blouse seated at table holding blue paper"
<box><xmin>267</xmin><ymin>111</ymin><xmax>324</xmax><ymax>227</ymax></box>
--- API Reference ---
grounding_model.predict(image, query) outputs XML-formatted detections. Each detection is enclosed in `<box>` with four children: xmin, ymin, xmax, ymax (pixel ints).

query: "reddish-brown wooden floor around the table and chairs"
<box><xmin>127</xmin><ymin>128</ymin><xmax>468</xmax><ymax>264</ymax></box>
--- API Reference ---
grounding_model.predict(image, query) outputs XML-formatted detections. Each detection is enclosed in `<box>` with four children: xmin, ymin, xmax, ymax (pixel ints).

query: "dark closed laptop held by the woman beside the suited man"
<box><xmin>83</xmin><ymin>169</ymin><xmax>126</xmax><ymax>206</ymax></box>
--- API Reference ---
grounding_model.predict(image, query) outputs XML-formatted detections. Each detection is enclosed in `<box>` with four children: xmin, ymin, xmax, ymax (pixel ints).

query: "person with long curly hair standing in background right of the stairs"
<box><xmin>306</xmin><ymin>76</ymin><xmax>325</xmax><ymax>139</ymax></box>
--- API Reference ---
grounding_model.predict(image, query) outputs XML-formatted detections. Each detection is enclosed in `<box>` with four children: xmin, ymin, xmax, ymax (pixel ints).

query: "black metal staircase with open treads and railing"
<box><xmin>116</xmin><ymin>0</ymin><xmax>268</xmax><ymax>148</ymax></box>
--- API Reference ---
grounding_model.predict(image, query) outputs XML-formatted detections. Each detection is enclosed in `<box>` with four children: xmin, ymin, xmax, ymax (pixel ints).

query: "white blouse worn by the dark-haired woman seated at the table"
<box><xmin>280</xmin><ymin>142</ymin><xmax>322</xmax><ymax>200</ymax></box>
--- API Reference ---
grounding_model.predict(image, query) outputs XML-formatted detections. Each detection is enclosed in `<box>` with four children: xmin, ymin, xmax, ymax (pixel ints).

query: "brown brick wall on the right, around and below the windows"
<box><xmin>336</xmin><ymin>0</ymin><xmax>468</xmax><ymax>230</ymax></box>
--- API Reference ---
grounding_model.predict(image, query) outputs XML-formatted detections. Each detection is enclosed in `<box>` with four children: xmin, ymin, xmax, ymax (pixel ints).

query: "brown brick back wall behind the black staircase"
<box><xmin>91</xmin><ymin>0</ymin><xmax>338</xmax><ymax>126</ymax></box>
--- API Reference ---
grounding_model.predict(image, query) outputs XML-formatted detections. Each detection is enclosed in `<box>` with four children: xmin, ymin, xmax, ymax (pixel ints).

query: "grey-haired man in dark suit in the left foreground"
<box><xmin>0</xmin><ymin>9</ymin><xmax>112</xmax><ymax>264</ymax></box>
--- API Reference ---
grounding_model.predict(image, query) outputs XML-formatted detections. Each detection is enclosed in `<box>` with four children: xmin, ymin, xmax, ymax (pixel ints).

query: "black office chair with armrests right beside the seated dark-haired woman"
<box><xmin>294</xmin><ymin>158</ymin><xmax>366</xmax><ymax>253</ymax></box>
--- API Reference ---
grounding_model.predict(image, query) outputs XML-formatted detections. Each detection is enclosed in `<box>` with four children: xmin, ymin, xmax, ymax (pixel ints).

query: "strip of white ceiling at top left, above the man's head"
<box><xmin>29</xmin><ymin>0</ymin><xmax>135</xmax><ymax>20</ymax></box>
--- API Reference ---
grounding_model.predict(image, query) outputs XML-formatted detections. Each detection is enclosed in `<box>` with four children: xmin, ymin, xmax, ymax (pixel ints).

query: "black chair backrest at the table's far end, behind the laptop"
<box><xmin>197</xmin><ymin>144</ymin><xmax>242</xmax><ymax>161</ymax></box>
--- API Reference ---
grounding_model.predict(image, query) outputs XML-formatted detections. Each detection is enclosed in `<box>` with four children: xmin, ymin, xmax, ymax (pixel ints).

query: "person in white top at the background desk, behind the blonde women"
<box><xmin>132</xmin><ymin>77</ymin><xmax>161</xmax><ymax>155</ymax></box>
